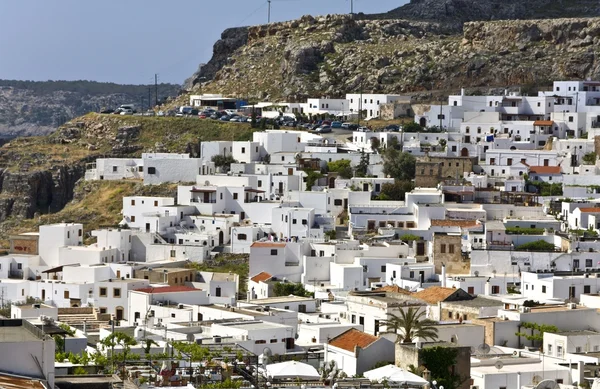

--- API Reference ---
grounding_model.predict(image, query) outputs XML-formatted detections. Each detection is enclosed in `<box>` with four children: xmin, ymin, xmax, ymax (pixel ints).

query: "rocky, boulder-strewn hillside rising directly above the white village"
<box><xmin>195</xmin><ymin>15</ymin><xmax>600</xmax><ymax>100</ymax></box>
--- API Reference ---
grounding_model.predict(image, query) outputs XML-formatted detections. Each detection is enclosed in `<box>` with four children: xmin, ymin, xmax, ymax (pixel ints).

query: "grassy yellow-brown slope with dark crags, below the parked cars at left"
<box><xmin>0</xmin><ymin>114</ymin><xmax>253</xmax><ymax>239</ymax></box>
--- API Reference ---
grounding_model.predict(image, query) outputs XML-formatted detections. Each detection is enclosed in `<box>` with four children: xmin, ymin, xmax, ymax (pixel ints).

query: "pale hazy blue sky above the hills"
<box><xmin>0</xmin><ymin>0</ymin><xmax>408</xmax><ymax>84</ymax></box>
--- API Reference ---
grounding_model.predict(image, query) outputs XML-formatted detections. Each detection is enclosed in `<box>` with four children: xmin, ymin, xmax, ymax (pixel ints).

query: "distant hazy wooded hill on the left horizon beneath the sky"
<box><xmin>0</xmin><ymin>80</ymin><xmax>181</xmax><ymax>138</ymax></box>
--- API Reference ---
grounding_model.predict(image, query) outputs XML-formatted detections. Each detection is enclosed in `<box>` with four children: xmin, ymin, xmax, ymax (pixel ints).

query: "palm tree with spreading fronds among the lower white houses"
<box><xmin>381</xmin><ymin>307</ymin><xmax>438</xmax><ymax>343</ymax></box>
